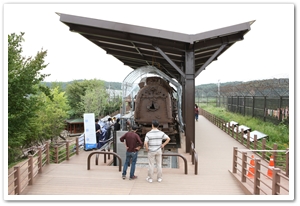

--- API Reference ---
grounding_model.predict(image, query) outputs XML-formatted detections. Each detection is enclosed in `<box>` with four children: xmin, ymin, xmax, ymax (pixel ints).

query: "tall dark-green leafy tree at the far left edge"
<box><xmin>8</xmin><ymin>33</ymin><xmax>50</xmax><ymax>163</ymax></box>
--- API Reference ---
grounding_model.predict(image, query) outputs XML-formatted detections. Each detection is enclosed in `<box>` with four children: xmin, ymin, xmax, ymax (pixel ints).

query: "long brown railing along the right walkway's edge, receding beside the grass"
<box><xmin>199</xmin><ymin>108</ymin><xmax>289</xmax><ymax>177</ymax></box>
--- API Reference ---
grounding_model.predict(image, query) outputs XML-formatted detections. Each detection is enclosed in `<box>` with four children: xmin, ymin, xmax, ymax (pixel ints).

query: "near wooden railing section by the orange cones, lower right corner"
<box><xmin>232</xmin><ymin>147</ymin><xmax>289</xmax><ymax>195</ymax></box>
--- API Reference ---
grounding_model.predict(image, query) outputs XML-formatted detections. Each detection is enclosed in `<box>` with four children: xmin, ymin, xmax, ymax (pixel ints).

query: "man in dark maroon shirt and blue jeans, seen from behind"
<box><xmin>120</xmin><ymin>125</ymin><xmax>143</xmax><ymax>180</ymax></box>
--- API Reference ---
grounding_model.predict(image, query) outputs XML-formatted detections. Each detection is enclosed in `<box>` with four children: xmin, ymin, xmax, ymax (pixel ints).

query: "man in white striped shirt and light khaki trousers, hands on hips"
<box><xmin>144</xmin><ymin>120</ymin><xmax>170</xmax><ymax>183</ymax></box>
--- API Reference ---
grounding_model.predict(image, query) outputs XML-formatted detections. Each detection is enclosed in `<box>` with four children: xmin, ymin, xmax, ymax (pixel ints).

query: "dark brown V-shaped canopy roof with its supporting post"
<box><xmin>58</xmin><ymin>13</ymin><xmax>254</xmax><ymax>151</ymax></box>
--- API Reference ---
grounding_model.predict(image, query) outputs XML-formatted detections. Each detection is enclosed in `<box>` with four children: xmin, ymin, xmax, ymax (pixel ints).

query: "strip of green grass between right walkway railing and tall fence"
<box><xmin>200</xmin><ymin>105</ymin><xmax>289</xmax><ymax>149</ymax></box>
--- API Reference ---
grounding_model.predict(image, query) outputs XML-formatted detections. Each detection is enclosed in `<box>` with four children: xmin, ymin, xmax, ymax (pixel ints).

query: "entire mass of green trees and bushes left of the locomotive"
<box><xmin>8</xmin><ymin>33</ymin><xmax>121</xmax><ymax>165</ymax></box>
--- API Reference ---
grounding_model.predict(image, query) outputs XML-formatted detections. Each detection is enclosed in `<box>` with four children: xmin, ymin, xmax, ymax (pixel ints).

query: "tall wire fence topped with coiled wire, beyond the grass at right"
<box><xmin>195</xmin><ymin>79</ymin><xmax>289</xmax><ymax>124</ymax></box>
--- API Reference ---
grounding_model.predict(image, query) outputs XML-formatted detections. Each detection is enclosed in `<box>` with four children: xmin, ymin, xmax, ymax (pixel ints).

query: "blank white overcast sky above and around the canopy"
<box><xmin>4</xmin><ymin>3</ymin><xmax>295</xmax><ymax>85</ymax></box>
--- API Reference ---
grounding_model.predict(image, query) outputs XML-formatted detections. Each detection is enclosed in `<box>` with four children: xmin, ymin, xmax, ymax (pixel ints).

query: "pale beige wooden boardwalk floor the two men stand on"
<box><xmin>16</xmin><ymin>115</ymin><xmax>278</xmax><ymax>201</ymax></box>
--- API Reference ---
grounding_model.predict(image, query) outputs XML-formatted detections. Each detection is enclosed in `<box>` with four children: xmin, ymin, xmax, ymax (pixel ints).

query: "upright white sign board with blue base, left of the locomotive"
<box><xmin>83</xmin><ymin>113</ymin><xmax>97</xmax><ymax>150</ymax></box>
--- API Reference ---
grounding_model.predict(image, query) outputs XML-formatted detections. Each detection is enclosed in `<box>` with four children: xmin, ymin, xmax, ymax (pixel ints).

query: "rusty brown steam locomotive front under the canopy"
<box><xmin>134</xmin><ymin>77</ymin><xmax>180</xmax><ymax>148</ymax></box>
